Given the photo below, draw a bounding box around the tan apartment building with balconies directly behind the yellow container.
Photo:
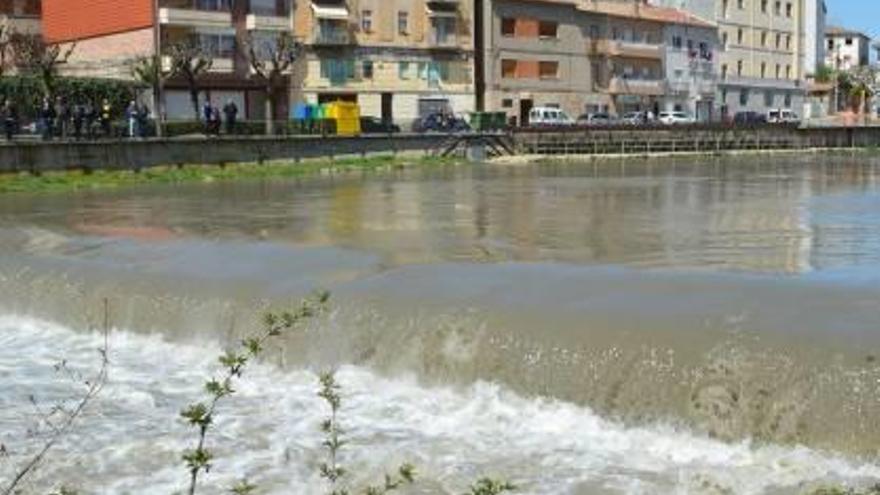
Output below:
[293,0,475,126]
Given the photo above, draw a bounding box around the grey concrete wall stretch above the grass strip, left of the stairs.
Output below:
[0,135,448,173]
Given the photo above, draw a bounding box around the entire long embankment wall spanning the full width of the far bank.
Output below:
[0,126,880,173]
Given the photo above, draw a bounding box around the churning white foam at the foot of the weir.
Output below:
[0,316,880,495]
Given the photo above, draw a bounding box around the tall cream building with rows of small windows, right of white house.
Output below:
[652,0,809,117]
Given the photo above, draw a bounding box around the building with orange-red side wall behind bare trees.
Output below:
[43,0,292,120]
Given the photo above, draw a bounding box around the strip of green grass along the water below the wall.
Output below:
[0,155,460,194]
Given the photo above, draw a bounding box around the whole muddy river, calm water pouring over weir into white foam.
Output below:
[0,153,880,495]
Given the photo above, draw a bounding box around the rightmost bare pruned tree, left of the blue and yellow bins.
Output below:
[242,31,302,135]
